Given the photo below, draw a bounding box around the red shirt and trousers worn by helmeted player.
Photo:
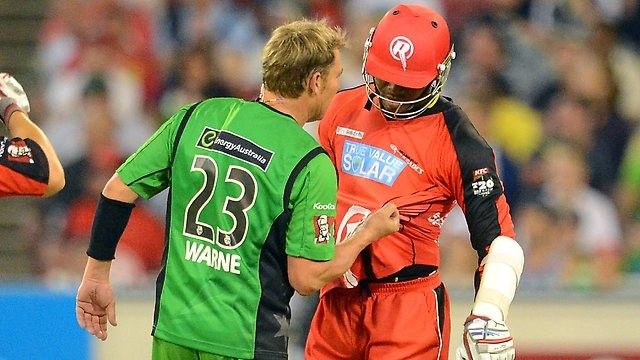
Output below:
[305,86,515,360]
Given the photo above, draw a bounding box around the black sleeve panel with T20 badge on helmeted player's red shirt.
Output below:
[443,103,502,258]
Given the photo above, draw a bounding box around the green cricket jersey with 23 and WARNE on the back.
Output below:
[118,98,337,359]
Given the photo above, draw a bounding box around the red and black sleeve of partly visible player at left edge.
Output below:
[0,137,49,197]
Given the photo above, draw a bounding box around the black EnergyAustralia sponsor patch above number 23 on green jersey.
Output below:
[196,127,273,171]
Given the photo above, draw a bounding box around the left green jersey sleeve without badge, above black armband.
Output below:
[116,107,188,199]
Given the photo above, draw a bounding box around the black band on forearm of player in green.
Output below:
[87,194,135,261]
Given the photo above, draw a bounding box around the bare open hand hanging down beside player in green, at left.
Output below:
[76,279,117,341]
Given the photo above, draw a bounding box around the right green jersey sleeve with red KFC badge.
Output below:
[286,153,338,261]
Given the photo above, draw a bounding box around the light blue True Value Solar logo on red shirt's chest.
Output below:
[341,140,407,186]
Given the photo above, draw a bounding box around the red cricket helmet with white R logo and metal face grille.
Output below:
[362,4,455,118]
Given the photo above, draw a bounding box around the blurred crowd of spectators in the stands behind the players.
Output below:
[0,0,640,291]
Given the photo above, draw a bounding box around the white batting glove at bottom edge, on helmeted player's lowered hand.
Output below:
[456,315,516,360]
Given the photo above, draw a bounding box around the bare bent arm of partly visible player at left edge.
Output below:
[8,111,65,196]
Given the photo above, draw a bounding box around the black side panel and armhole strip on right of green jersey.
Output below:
[255,147,324,360]
